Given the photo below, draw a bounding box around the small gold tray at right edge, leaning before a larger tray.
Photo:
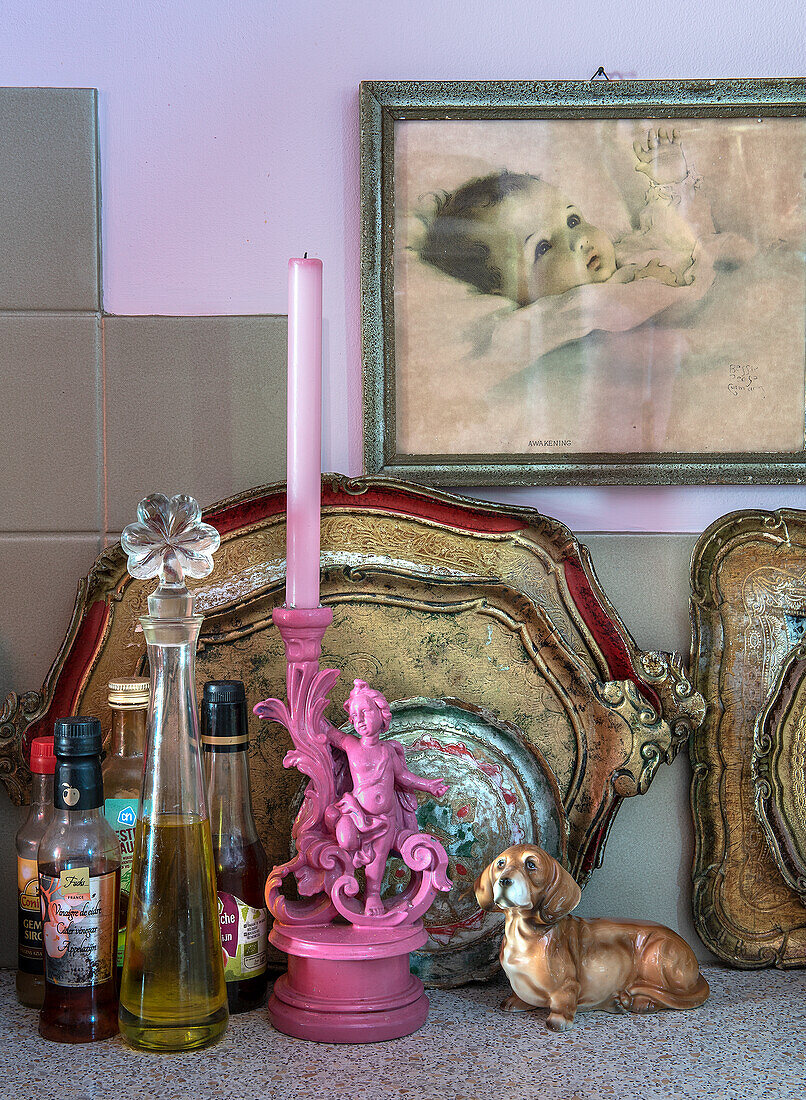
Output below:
[753,642,806,904]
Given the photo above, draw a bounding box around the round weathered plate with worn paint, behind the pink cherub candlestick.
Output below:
[378,699,567,987]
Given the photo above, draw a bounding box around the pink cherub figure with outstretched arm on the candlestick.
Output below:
[320,680,448,916]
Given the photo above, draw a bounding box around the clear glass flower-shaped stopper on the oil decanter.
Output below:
[120,493,221,618]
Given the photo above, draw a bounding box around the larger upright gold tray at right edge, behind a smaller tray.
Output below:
[691,509,806,968]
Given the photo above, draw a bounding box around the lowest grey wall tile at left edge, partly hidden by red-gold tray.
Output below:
[0,535,99,700]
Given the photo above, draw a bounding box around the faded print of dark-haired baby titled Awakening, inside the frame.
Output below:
[395,118,806,457]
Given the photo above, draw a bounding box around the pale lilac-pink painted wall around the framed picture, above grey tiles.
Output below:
[0,0,806,531]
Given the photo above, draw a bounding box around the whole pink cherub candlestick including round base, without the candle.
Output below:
[254,607,451,1043]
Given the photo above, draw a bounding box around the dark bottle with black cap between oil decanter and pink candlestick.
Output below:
[201,680,268,1013]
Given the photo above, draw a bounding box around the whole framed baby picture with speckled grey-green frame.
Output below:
[361,79,806,485]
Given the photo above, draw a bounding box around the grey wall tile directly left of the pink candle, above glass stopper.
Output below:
[104,316,287,530]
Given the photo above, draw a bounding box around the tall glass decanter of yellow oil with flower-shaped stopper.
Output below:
[119,495,229,1051]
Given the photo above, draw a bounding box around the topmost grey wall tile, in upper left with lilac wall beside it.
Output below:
[0,88,100,310]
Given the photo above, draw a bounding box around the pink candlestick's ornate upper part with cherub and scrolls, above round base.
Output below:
[254,608,450,928]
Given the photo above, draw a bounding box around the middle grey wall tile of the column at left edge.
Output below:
[0,314,102,532]
